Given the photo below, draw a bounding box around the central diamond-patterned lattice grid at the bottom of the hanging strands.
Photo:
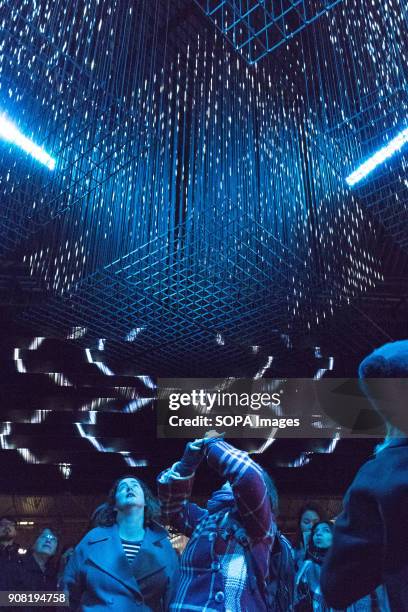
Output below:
[19,209,328,372]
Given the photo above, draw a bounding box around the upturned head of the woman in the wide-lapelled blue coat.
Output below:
[92,475,160,527]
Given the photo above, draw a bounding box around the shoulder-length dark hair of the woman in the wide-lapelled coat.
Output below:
[91,474,160,527]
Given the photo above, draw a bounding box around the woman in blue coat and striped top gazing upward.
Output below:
[63,476,178,612]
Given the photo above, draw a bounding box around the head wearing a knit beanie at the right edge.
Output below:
[358,340,408,435]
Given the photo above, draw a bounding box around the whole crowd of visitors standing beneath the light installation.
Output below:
[0,341,408,612]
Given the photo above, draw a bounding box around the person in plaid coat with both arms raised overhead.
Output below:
[158,434,277,612]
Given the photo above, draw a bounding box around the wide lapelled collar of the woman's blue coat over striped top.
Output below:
[87,523,167,596]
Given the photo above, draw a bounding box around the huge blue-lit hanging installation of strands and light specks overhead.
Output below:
[0,0,407,373]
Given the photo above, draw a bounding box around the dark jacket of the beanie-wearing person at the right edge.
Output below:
[321,438,408,612]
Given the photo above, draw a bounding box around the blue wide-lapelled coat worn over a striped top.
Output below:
[62,525,178,612]
